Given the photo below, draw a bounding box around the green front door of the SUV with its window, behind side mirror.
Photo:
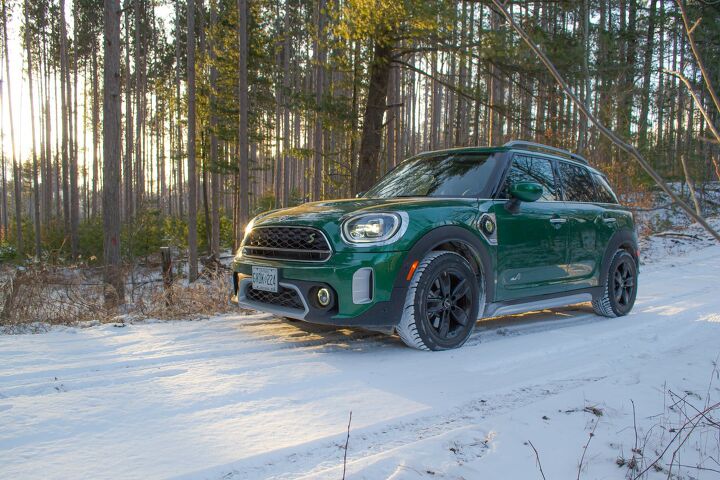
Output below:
[493,154,569,301]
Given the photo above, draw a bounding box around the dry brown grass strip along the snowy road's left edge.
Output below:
[0,258,238,333]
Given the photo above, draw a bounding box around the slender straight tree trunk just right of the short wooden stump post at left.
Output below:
[187,0,198,282]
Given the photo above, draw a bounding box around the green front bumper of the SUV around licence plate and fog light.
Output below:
[233,252,407,328]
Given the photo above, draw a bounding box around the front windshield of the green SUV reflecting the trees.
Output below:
[363,152,497,198]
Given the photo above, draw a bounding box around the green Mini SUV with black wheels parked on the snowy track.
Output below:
[233,141,638,350]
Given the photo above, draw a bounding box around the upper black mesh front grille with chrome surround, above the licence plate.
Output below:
[243,227,332,262]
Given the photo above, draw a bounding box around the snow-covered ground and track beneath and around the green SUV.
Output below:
[0,227,720,480]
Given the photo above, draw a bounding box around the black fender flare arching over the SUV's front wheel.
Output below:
[394,225,495,303]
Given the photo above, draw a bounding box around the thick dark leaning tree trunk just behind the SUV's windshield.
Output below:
[357,39,393,192]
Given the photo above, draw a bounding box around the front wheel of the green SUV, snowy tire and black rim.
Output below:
[396,251,480,350]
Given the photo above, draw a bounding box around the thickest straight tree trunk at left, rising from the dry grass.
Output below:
[102,0,125,305]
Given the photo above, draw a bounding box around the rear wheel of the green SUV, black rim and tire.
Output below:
[592,250,638,318]
